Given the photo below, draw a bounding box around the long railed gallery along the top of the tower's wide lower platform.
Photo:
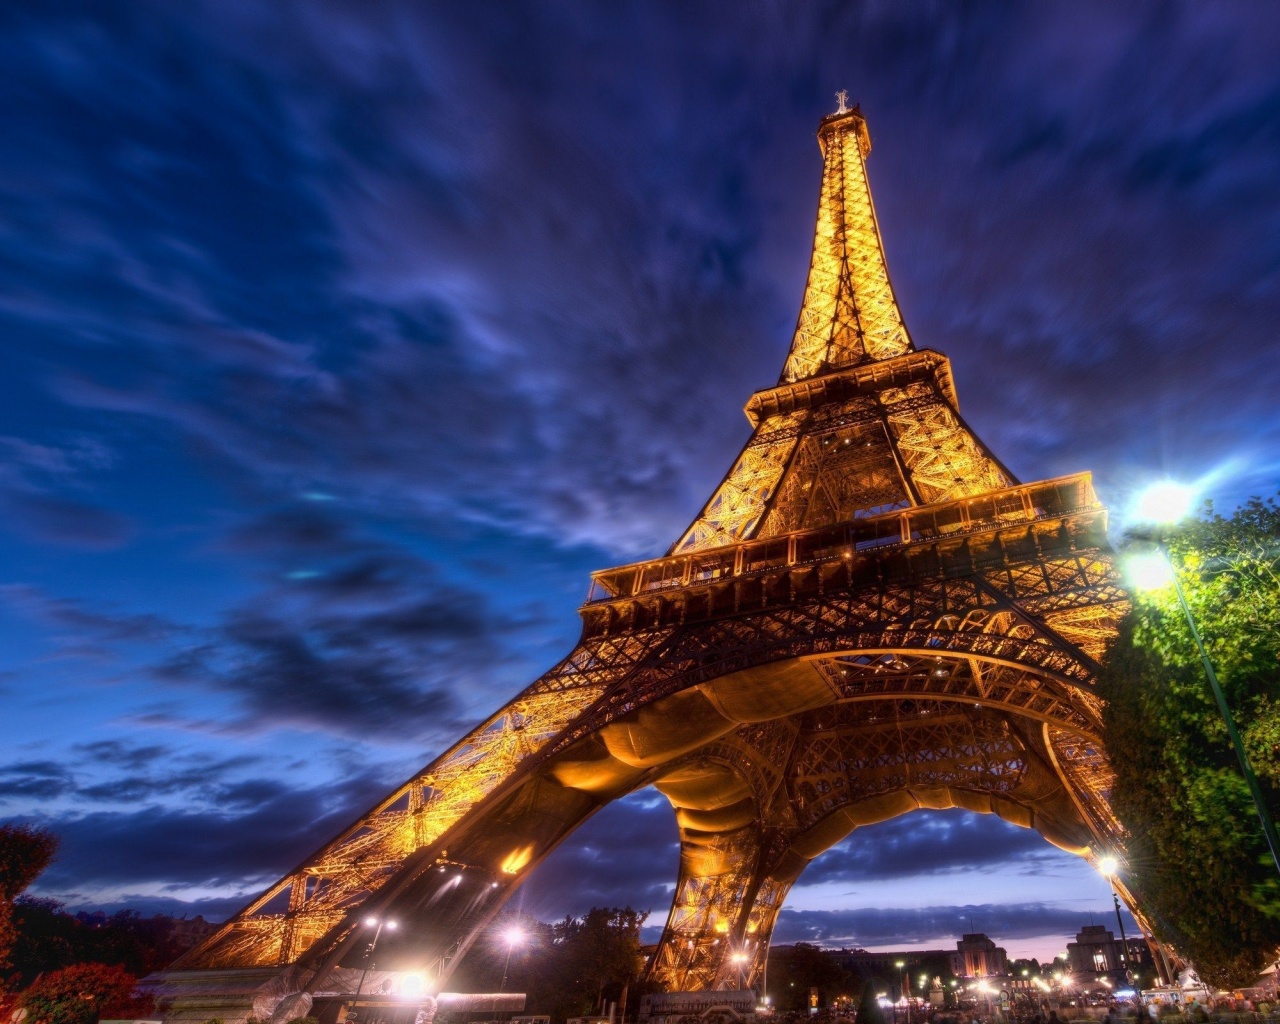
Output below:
[586,472,1101,604]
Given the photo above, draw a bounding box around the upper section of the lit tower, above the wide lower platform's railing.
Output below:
[671,108,1016,554]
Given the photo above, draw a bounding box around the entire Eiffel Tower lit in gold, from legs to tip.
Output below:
[162,101,1134,1020]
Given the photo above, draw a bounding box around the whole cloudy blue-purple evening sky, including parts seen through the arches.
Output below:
[0,0,1280,952]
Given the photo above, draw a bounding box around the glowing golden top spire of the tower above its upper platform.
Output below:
[782,104,914,383]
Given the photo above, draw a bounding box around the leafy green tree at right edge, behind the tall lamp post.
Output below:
[1098,498,1280,987]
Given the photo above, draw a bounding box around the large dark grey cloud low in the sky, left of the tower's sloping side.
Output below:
[155,540,527,741]
